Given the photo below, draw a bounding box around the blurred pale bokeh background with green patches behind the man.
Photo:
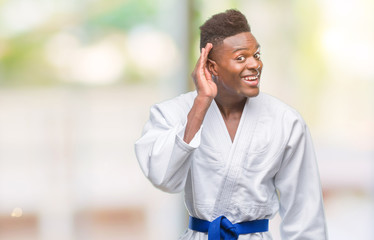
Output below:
[0,0,374,240]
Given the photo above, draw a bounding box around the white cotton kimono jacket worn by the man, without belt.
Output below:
[135,92,327,240]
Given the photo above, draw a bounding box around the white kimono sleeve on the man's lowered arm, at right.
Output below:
[275,113,327,240]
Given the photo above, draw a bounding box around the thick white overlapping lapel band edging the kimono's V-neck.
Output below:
[212,95,261,219]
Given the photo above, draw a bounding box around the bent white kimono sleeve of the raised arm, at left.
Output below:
[135,105,201,193]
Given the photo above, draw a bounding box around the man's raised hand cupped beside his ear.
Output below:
[192,43,217,100]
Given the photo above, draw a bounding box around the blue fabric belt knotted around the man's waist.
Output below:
[188,216,269,240]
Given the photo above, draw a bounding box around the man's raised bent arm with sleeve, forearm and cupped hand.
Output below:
[135,44,217,192]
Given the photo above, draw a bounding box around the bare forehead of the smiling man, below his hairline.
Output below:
[221,32,260,53]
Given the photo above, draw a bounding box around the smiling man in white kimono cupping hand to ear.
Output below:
[135,10,327,240]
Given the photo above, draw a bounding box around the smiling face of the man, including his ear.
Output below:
[208,32,263,97]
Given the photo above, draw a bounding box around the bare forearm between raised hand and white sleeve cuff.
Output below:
[183,96,213,144]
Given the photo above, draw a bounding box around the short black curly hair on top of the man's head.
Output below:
[200,9,251,49]
